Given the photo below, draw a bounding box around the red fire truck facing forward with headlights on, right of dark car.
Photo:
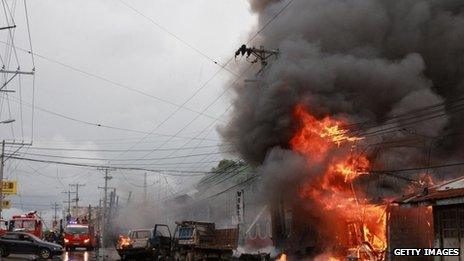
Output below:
[63,223,97,251]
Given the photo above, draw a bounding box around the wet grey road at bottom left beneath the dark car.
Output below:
[1,248,120,261]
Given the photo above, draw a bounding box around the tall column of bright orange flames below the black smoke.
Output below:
[289,105,387,260]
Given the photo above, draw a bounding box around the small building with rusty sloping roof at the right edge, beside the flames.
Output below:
[396,177,464,260]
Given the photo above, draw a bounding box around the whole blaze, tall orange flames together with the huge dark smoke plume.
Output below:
[220,0,464,260]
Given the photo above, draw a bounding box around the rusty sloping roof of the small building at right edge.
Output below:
[395,177,464,205]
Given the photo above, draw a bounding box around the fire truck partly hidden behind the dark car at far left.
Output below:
[8,211,43,238]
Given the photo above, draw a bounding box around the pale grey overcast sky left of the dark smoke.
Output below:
[0,0,256,223]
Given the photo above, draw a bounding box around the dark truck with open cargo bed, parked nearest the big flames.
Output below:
[172,221,238,261]
